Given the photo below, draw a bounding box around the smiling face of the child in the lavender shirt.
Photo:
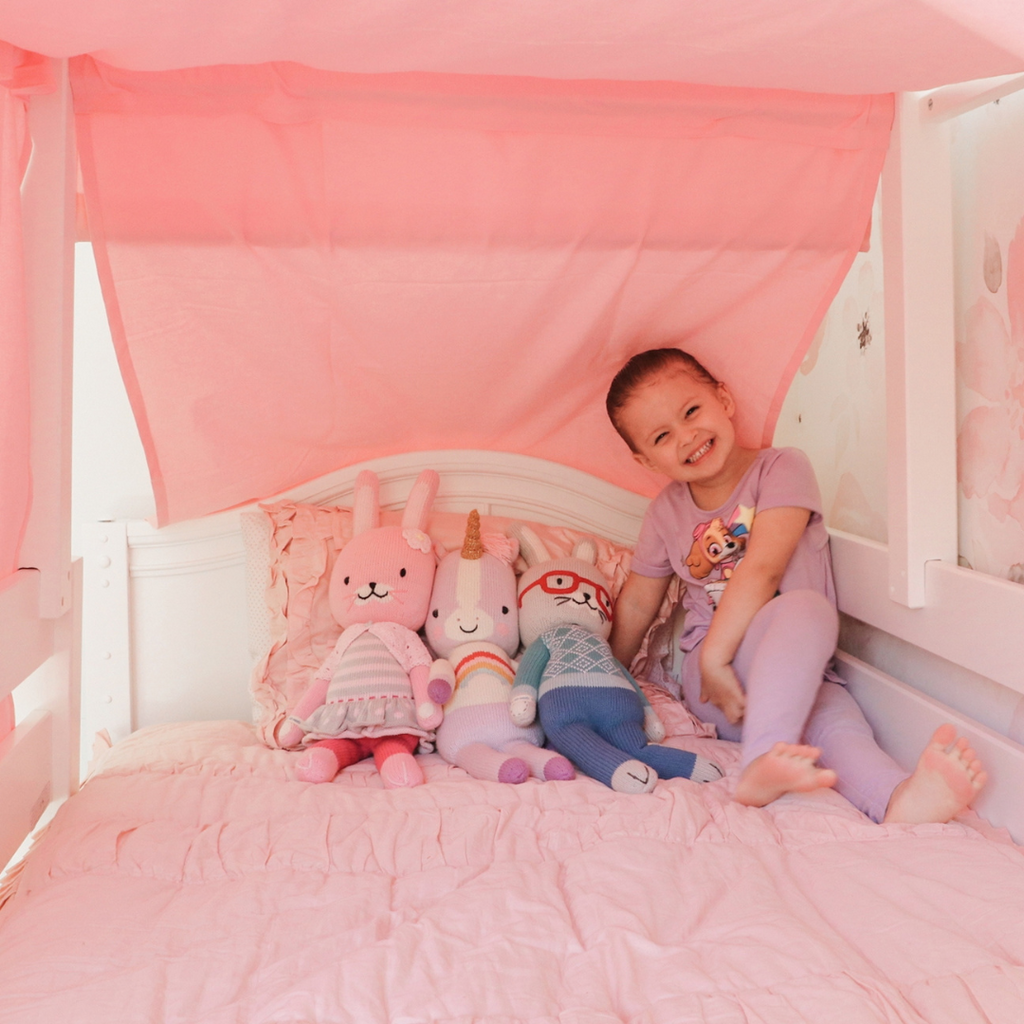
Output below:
[618,369,736,484]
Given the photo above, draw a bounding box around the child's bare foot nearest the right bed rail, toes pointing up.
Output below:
[882,722,988,824]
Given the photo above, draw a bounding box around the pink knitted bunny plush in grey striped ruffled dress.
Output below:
[278,470,452,788]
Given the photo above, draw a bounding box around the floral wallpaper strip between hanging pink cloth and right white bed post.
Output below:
[774,192,887,542]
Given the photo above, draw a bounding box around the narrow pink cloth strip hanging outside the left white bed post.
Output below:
[0,43,48,585]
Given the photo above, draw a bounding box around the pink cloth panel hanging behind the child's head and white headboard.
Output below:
[73,57,892,522]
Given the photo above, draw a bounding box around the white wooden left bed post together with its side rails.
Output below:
[0,60,81,868]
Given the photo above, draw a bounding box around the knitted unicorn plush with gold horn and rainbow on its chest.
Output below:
[427,510,575,782]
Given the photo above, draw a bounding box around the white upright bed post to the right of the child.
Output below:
[882,93,957,608]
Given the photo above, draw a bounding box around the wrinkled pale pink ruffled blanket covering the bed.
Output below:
[0,723,1024,1024]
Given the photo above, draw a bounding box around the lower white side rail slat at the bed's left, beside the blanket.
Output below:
[0,711,53,866]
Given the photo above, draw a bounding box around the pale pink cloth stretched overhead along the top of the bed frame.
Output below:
[0,0,1024,93]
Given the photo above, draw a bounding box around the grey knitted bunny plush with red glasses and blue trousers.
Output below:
[509,523,722,793]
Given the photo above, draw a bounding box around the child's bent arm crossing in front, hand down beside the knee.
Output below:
[700,507,811,722]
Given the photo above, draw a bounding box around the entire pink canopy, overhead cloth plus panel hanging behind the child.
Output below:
[0,0,1024,522]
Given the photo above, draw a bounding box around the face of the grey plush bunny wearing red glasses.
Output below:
[519,558,611,646]
